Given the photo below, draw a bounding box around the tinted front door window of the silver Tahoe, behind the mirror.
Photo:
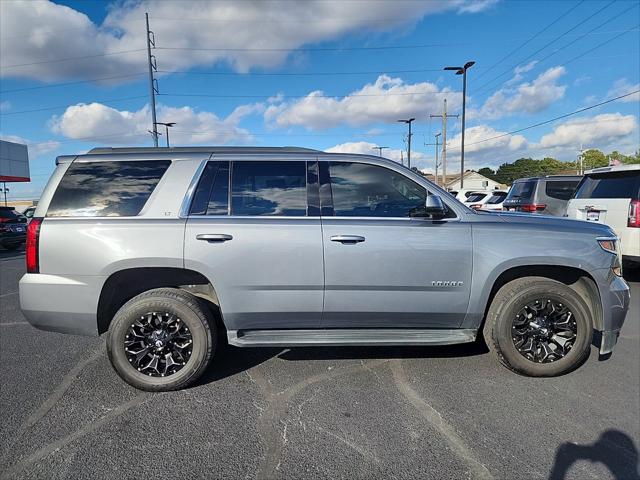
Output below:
[329,162,426,217]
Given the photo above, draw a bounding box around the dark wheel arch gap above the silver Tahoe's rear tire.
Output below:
[97,267,224,334]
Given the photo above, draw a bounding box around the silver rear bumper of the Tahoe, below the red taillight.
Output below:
[19,273,106,336]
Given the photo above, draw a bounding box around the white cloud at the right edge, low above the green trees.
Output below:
[540,113,638,149]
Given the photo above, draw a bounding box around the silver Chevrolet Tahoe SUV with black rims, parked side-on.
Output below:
[20,147,629,391]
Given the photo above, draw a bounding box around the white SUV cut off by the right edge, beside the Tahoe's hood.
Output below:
[567,165,640,268]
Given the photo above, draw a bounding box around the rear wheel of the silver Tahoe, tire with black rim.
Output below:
[107,288,217,392]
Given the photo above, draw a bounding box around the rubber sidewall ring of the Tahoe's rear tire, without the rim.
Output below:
[107,296,213,390]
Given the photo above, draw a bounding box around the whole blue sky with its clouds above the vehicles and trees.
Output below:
[0,0,640,198]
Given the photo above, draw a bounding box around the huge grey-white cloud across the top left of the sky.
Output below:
[0,0,495,81]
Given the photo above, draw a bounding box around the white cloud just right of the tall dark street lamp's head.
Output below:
[469,66,567,119]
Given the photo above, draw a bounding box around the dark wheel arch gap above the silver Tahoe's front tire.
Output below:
[480,265,604,331]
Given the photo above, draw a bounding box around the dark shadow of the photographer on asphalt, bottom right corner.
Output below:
[549,430,640,480]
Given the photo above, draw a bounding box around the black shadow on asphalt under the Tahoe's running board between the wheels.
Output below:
[194,341,489,386]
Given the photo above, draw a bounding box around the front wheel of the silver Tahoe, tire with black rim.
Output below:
[483,277,593,377]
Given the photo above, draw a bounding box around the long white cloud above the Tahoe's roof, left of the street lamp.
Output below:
[265,75,459,129]
